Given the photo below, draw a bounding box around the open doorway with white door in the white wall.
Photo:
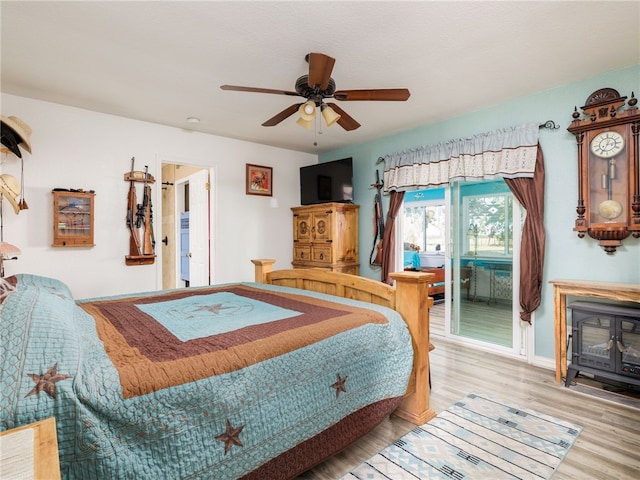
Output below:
[162,163,214,289]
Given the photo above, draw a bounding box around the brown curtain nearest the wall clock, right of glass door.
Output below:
[504,144,545,323]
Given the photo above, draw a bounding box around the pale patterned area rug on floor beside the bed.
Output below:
[341,394,582,480]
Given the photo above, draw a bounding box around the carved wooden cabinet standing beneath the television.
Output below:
[291,203,360,275]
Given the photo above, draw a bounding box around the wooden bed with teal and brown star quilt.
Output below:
[0,260,434,479]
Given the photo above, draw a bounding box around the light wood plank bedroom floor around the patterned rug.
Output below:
[298,312,640,480]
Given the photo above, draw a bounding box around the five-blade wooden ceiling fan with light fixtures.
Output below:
[220,53,411,131]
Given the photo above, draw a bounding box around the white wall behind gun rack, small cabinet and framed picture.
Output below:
[0,94,317,298]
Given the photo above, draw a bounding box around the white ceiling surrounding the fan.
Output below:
[0,1,640,153]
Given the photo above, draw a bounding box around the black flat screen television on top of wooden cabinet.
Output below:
[300,158,353,205]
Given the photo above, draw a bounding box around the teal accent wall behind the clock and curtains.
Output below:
[319,65,640,359]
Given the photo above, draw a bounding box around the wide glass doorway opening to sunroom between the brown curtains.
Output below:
[400,180,526,355]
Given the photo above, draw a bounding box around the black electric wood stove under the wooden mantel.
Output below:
[565,301,640,387]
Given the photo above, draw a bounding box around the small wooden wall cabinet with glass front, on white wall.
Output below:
[52,190,95,247]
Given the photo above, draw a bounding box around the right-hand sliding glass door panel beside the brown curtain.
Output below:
[451,181,520,349]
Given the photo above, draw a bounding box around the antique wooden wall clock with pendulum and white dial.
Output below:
[567,88,640,254]
